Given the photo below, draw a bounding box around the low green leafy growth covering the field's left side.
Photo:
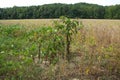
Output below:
[0,25,32,80]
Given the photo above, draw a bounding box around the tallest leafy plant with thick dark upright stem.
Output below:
[55,16,83,61]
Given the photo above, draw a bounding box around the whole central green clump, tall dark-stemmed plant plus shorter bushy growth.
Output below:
[27,16,83,63]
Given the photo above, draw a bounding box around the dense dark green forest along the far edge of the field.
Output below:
[0,3,120,19]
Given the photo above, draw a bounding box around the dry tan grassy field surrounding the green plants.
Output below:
[0,19,120,80]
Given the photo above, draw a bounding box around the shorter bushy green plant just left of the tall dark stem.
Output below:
[29,27,64,64]
